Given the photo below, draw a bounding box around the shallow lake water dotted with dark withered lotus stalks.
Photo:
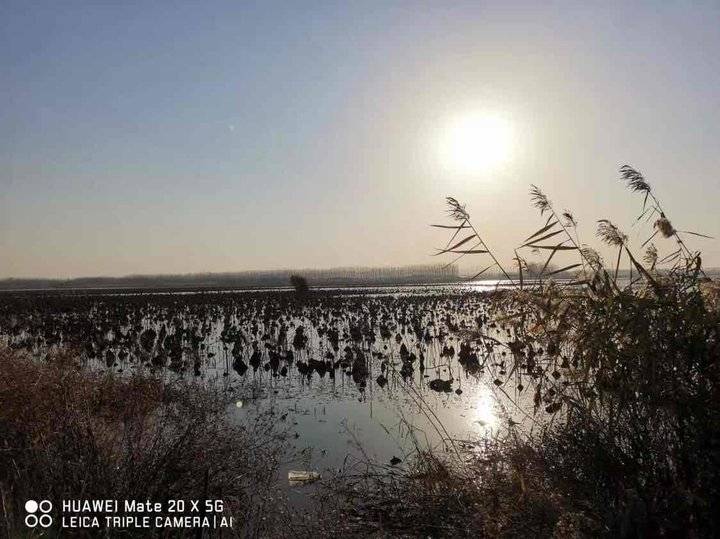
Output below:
[0,281,531,499]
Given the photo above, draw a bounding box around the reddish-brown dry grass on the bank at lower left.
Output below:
[0,351,283,537]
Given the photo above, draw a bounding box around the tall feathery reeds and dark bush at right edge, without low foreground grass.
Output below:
[416,162,720,537]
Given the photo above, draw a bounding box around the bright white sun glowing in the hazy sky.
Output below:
[439,112,513,174]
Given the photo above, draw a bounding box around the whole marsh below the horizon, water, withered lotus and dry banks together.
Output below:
[0,259,720,537]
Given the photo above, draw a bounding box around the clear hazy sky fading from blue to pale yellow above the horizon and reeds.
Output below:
[0,0,720,278]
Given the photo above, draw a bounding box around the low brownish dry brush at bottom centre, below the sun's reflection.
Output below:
[298,440,576,538]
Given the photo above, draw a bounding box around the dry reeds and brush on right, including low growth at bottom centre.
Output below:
[314,166,720,537]
